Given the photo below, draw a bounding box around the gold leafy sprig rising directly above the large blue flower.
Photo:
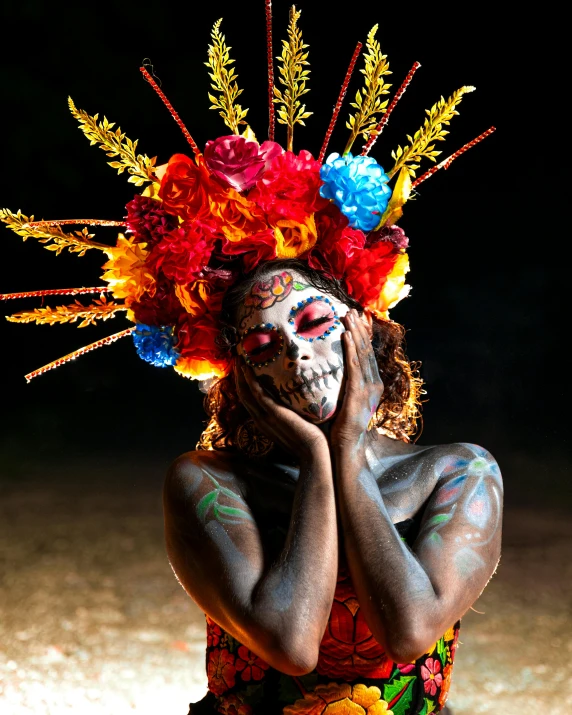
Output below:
[344,25,391,156]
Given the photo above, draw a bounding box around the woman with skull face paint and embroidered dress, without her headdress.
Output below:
[164,261,502,715]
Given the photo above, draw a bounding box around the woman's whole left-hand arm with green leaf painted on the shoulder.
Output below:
[164,366,338,675]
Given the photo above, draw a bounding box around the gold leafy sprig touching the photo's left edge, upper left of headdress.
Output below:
[0,209,111,256]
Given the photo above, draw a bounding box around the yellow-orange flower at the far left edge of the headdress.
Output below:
[101,233,155,304]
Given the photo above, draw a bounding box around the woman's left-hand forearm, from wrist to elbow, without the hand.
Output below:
[252,446,338,659]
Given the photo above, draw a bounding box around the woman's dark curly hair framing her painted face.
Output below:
[197,259,423,450]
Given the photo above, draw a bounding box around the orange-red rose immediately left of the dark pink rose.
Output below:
[159,154,211,219]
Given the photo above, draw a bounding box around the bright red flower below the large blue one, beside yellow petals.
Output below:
[344,241,401,305]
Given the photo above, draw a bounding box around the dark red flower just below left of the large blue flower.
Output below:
[308,204,366,278]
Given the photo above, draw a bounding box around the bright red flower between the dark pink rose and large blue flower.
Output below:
[249,150,328,223]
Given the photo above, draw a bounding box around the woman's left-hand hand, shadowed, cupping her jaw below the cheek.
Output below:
[235,359,329,462]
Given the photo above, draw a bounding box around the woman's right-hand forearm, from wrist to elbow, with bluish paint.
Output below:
[335,450,439,662]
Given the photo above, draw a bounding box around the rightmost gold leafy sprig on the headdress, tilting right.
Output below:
[388,85,475,178]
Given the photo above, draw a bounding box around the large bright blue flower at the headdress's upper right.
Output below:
[320,153,391,231]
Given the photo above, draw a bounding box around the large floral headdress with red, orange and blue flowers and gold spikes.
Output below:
[0,0,494,382]
